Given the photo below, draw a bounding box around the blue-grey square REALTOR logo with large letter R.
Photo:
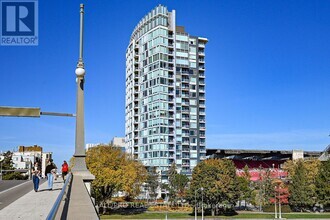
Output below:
[1,0,38,46]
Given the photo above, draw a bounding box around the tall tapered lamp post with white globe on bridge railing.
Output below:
[72,4,95,184]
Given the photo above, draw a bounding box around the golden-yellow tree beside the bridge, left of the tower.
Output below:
[86,145,147,208]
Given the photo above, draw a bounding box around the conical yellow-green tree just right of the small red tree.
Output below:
[289,160,313,210]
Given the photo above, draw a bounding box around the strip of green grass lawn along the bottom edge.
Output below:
[101,212,330,219]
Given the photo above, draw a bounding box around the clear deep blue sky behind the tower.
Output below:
[0,0,330,163]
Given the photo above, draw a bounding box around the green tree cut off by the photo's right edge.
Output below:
[315,160,330,206]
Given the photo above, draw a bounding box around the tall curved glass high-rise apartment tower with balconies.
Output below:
[125,5,208,181]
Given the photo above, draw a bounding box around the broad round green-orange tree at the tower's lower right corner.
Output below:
[187,159,239,216]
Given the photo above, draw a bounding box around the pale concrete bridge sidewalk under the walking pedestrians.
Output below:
[0,177,64,220]
